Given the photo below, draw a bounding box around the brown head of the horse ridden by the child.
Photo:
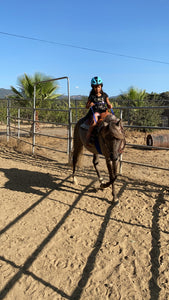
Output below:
[100,116,125,161]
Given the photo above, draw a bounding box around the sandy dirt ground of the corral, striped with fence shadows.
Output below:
[0,127,169,300]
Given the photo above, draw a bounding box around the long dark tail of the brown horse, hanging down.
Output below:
[73,122,83,168]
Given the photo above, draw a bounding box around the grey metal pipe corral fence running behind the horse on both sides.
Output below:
[0,91,169,172]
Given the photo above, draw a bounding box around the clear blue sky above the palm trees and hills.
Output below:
[0,0,169,96]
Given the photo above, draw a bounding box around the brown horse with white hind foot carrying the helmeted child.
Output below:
[73,114,125,201]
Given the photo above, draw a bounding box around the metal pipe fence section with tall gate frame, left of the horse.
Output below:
[7,76,72,161]
